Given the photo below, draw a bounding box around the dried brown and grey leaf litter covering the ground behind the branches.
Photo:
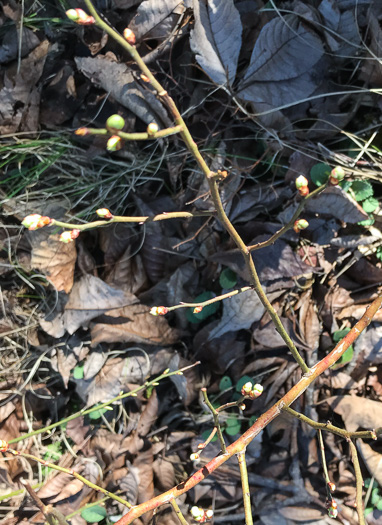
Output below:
[0,0,382,525]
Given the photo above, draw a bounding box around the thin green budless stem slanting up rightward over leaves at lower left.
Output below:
[9,361,200,444]
